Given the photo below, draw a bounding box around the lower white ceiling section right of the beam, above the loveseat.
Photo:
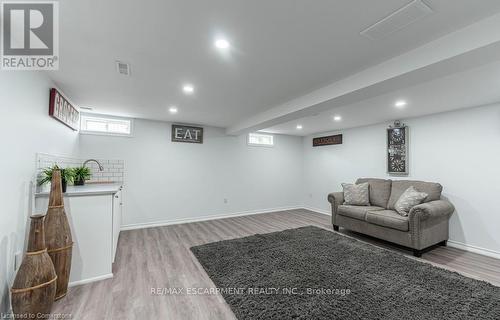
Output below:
[262,58,500,136]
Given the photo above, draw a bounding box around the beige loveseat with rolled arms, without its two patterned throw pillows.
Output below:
[328,178,455,257]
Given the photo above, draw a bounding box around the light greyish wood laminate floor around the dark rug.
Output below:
[53,210,500,320]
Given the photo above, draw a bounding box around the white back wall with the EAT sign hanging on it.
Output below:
[80,120,303,226]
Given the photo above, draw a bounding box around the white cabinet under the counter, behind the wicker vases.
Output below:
[35,185,123,285]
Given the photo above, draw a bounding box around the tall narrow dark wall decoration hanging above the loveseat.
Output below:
[387,121,409,175]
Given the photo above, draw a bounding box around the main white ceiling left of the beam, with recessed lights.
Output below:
[49,0,500,134]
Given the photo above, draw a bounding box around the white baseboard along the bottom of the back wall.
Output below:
[121,206,303,231]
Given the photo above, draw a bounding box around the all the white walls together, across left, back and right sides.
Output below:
[0,72,500,312]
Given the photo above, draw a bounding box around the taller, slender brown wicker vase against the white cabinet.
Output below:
[45,170,73,300]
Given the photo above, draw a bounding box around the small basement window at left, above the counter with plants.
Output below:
[80,115,132,136]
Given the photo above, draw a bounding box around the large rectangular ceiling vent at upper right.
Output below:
[361,0,433,40]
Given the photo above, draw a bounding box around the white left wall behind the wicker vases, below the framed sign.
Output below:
[0,71,78,312]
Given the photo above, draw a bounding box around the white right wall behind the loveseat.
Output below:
[303,104,500,253]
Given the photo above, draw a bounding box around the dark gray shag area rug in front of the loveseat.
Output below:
[191,226,500,320]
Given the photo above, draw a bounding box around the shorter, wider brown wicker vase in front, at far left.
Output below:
[11,215,57,319]
